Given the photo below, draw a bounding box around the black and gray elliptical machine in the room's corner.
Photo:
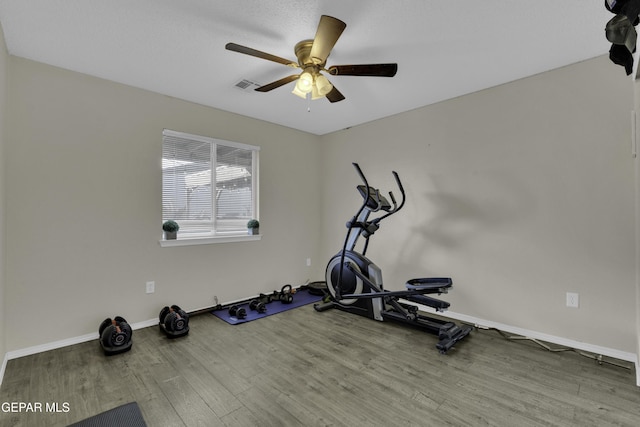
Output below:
[314,163,472,354]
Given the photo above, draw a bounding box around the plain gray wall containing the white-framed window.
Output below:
[3,57,321,351]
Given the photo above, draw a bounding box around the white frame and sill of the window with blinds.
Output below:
[160,129,261,247]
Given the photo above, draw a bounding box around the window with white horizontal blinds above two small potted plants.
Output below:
[162,129,260,238]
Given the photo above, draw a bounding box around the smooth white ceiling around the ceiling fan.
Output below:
[0,0,624,135]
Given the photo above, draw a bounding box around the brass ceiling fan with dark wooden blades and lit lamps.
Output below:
[225,15,398,102]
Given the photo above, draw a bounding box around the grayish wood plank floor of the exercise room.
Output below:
[0,305,640,427]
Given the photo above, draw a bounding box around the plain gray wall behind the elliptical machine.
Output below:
[322,56,638,354]
